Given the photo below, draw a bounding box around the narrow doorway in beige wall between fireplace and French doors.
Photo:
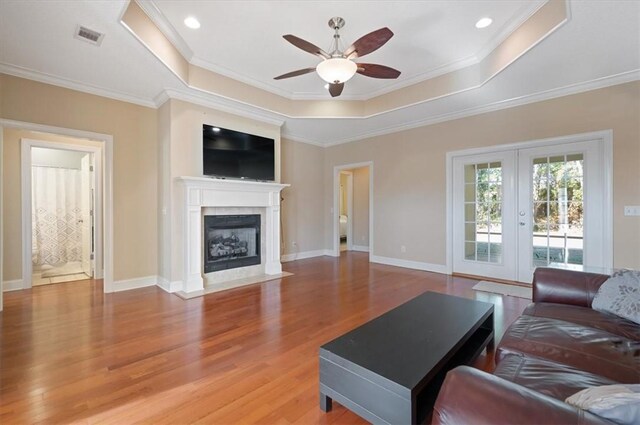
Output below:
[332,162,373,256]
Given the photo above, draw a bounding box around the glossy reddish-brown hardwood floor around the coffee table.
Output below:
[0,252,528,424]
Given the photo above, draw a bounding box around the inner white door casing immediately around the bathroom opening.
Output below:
[20,138,104,289]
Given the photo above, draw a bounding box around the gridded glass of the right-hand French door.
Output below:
[532,154,584,267]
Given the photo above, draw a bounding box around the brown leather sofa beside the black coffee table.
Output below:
[432,268,640,424]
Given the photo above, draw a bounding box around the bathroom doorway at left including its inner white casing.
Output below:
[21,138,103,289]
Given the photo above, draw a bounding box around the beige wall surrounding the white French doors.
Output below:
[324,82,640,268]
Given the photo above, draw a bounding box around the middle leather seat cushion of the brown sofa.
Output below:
[496,315,640,383]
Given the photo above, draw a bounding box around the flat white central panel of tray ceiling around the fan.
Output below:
[150,0,544,99]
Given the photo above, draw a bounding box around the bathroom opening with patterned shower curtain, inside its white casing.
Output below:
[31,146,95,286]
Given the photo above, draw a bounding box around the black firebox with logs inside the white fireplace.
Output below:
[204,214,261,273]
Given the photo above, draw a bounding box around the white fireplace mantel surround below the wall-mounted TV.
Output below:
[176,177,290,293]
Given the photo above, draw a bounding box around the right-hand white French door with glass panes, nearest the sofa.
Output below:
[518,141,606,282]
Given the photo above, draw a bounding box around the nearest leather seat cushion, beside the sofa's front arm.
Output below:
[494,354,617,401]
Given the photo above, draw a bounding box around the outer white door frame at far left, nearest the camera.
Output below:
[0,119,113,293]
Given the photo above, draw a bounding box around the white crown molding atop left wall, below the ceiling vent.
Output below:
[0,63,156,108]
